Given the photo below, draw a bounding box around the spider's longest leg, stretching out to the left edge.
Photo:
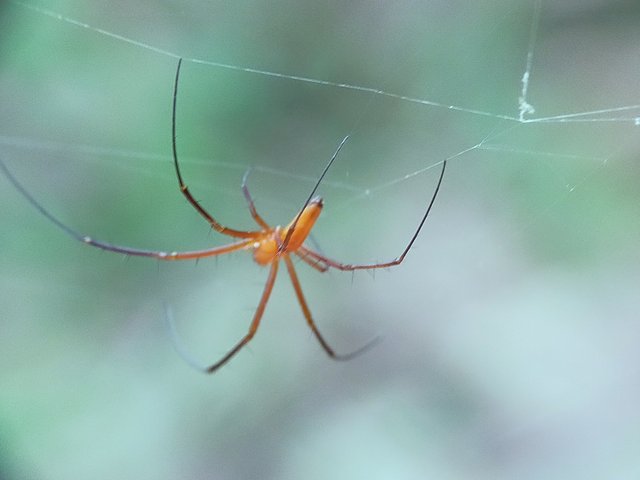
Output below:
[0,159,253,260]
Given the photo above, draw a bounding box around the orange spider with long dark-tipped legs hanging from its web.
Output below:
[0,59,446,373]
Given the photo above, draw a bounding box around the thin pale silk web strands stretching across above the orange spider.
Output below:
[0,0,640,207]
